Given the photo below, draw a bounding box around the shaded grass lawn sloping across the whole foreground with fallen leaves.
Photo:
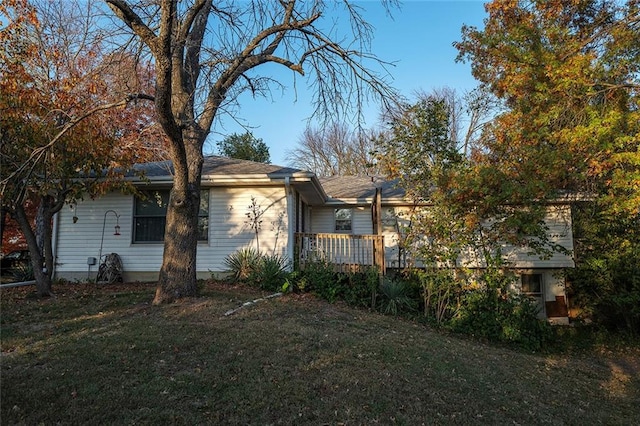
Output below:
[0,283,640,425]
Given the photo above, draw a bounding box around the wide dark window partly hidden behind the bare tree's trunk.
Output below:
[133,190,209,243]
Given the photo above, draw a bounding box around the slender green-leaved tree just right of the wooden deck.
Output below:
[378,95,475,322]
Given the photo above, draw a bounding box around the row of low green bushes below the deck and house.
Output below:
[292,260,552,351]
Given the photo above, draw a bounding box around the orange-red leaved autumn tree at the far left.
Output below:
[0,0,160,296]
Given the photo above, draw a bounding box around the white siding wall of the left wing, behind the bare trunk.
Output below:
[55,186,288,281]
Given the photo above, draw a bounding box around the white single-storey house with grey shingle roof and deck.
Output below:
[54,156,574,317]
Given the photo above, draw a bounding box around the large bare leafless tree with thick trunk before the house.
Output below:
[105,0,390,304]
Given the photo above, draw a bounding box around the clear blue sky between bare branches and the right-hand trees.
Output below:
[205,0,486,166]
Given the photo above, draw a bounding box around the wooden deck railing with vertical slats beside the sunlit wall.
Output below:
[296,233,385,274]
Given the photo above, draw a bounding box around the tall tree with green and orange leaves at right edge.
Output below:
[457,0,640,330]
